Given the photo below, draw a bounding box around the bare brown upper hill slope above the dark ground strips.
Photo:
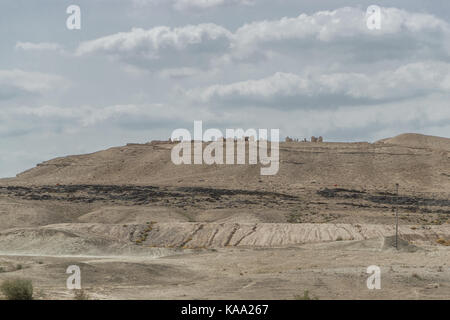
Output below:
[0,134,450,193]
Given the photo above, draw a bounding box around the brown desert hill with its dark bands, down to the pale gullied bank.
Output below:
[0,134,450,229]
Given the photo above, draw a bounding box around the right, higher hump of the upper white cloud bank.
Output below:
[233,7,450,58]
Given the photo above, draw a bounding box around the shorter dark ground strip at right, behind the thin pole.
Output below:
[317,188,450,214]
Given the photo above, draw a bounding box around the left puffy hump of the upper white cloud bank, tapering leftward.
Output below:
[76,23,232,70]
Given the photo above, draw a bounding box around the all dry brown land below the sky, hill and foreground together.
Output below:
[0,134,450,299]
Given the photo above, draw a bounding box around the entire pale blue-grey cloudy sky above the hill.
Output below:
[0,0,450,177]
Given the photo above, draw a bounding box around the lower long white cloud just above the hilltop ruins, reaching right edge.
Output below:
[186,62,450,107]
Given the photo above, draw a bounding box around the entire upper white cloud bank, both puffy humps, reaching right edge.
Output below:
[77,6,450,70]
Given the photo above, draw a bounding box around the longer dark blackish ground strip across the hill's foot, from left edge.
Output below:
[0,185,300,208]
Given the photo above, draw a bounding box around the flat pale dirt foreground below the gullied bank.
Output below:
[0,240,450,299]
